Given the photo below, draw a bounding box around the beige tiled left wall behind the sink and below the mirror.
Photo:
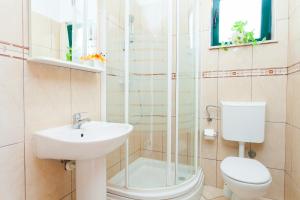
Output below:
[0,0,100,200]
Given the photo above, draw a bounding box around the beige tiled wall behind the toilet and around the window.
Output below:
[201,0,289,200]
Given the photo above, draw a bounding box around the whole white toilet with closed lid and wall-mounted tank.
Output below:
[220,101,272,200]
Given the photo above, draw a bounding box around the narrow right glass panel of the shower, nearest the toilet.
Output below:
[176,0,196,183]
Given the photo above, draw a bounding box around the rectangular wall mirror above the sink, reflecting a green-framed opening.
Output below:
[30,0,103,66]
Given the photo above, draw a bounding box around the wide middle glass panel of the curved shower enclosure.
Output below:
[128,0,168,188]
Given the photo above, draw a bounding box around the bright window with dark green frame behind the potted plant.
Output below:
[211,0,272,46]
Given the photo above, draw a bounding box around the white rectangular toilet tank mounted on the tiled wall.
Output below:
[221,101,266,143]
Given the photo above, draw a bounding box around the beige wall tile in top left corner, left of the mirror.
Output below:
[0,0,23,45]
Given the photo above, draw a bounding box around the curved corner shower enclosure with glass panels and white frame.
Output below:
[100,0,203,200]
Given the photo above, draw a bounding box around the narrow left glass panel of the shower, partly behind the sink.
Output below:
[105,0,125,187]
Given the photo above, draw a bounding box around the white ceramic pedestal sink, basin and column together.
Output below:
[33,121,133,200]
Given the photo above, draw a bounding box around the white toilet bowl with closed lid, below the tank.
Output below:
[221,157,272,200]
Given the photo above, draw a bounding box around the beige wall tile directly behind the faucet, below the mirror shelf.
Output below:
[71,69,100,120]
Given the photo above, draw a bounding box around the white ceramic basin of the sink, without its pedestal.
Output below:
[33,121,133,160]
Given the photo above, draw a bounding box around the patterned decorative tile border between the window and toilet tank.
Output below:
[202,67,288,78]
